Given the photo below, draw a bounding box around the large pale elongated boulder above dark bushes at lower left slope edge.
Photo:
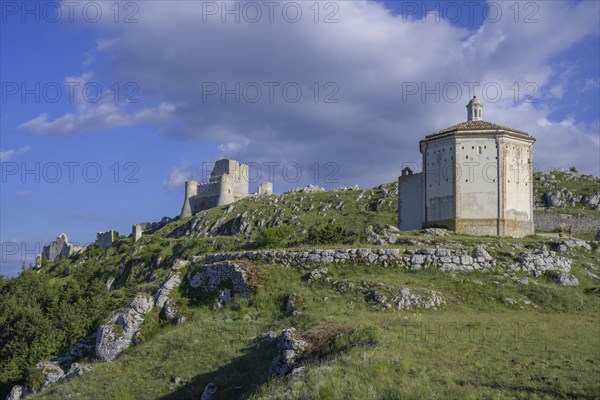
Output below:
[96,294,154,361]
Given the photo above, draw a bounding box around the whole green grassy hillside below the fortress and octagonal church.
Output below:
[0,180,600,399]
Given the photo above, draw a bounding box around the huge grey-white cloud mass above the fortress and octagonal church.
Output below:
[22,1,600,187]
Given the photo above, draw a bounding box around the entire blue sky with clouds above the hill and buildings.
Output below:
[0,0,600,275]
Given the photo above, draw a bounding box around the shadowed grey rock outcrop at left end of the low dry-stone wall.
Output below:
[189,261,251,297]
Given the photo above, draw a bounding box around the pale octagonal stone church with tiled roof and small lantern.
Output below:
[398,97,535,237]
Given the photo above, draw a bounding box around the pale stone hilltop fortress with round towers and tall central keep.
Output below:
[180,159,273,217]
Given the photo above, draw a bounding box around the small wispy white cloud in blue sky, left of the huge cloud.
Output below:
[19,72,175,136]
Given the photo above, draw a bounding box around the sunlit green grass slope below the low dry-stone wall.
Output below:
[32,266,600,400]
